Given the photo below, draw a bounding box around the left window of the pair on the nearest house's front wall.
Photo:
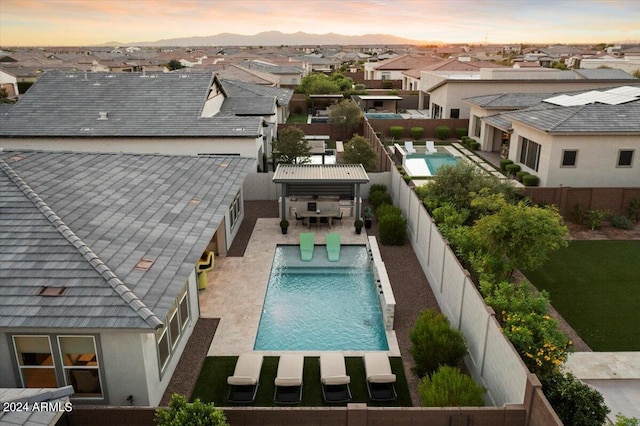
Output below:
[13,336,58,388]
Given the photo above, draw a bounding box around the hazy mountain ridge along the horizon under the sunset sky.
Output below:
[114,31,433,46]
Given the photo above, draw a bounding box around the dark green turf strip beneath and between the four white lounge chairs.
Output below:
[191,356,411,407]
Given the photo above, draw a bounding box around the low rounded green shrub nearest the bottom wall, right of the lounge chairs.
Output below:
[418,366,486,407]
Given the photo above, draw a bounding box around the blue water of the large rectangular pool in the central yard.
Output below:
[254,245,389,351]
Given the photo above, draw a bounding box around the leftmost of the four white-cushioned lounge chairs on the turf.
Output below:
[227,353,263,404]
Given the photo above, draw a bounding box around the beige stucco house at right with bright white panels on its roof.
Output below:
[468,84,640,187]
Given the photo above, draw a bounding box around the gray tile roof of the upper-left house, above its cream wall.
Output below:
[0,71,261,138]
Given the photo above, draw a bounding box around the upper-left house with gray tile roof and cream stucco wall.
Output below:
[0,71,276,165]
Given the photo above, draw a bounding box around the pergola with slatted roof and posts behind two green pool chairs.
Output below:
[272,164,369,219]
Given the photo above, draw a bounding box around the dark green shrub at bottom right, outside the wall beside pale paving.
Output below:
[540,373,609,426]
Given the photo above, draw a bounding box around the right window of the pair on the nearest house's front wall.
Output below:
[58,336,103,398]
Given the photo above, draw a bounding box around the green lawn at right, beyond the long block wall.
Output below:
[526,240,640,352]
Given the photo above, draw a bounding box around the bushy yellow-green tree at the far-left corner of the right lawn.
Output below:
[471,200,568,275]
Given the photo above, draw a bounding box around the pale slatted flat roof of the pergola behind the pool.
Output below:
[273,164,369,183]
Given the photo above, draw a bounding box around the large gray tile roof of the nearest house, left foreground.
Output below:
[0,151,255,329]
